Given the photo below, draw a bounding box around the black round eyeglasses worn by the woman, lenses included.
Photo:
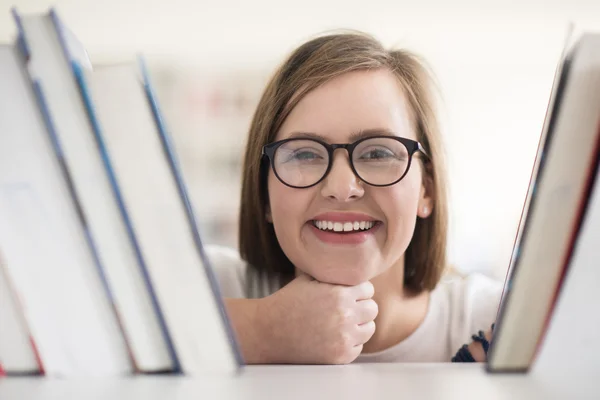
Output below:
[262,135,429,189]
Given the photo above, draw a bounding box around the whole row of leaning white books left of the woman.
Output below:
[0,9,242,377]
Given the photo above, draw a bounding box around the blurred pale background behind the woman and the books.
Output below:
[0,0,600,279]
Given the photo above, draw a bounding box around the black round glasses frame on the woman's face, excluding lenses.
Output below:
[261,135,430,189]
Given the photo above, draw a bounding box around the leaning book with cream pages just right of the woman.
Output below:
[486,33,600,372]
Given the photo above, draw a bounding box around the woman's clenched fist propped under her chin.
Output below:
[259,274,378,364]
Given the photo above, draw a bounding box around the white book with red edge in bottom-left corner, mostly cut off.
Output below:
[0,247,41,374]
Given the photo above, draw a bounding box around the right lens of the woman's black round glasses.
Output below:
[352,138,410,185]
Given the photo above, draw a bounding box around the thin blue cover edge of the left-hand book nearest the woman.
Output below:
[139,58,244,367]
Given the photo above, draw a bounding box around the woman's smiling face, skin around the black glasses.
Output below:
[267,69,432,285]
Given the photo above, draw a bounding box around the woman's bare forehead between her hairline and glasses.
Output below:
[276,69,416,143]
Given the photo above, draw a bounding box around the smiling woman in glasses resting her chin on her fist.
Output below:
[209,32,502,363]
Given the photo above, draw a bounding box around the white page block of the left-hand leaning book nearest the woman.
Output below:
[83,60,241,376]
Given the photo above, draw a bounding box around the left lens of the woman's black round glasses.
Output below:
[274,139,329,187]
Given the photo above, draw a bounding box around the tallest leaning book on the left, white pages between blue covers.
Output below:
[12,10,177,372]
